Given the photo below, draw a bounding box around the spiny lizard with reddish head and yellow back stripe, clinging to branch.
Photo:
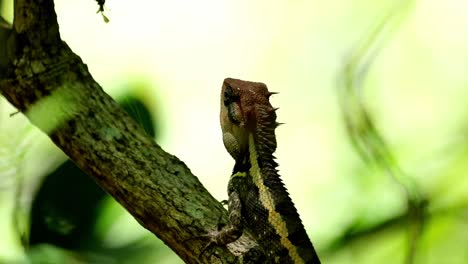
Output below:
[209,78,320,264]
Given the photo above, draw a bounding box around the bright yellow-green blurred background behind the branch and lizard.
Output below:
[0,0,468,264]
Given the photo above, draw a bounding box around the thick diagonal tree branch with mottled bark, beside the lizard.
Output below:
[0,0,253,263]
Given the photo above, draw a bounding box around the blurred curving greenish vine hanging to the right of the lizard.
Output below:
[338,1,427,263]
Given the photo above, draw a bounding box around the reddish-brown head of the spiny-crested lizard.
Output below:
[220,78,273,161]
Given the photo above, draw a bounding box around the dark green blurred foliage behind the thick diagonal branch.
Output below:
[23,95,166,263]
